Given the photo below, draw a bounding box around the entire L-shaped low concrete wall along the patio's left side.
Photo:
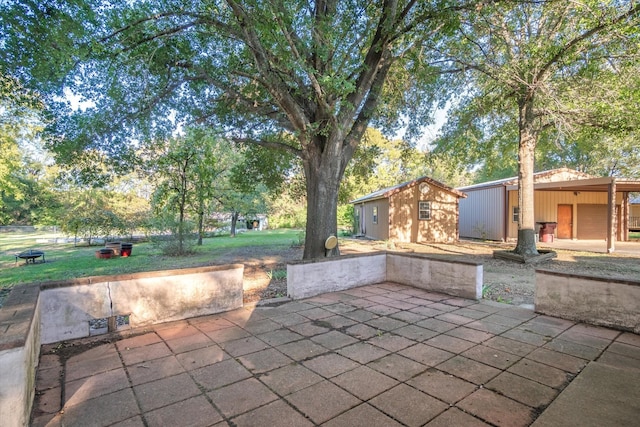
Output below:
[0,264,244,427]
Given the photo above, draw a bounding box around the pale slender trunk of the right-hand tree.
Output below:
[515,97,539,257]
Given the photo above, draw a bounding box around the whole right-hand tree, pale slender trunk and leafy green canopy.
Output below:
[432,1,640,256]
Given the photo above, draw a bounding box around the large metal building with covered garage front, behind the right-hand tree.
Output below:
[458,168,640,251]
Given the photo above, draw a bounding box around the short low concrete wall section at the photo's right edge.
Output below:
[535,269,640,334]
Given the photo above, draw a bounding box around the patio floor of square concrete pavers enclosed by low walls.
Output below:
[32,283,640,427]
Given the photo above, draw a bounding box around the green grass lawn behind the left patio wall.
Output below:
[0,229,300,289]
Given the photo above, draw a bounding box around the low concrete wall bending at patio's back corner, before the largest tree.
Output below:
[287,252,482,299]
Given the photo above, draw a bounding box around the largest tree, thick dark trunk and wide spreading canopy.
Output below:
[2,0,461,258]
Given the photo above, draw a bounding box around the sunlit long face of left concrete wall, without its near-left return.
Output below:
[40,265,244,344]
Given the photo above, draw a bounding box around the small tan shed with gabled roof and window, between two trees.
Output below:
[351,177,466,243]
